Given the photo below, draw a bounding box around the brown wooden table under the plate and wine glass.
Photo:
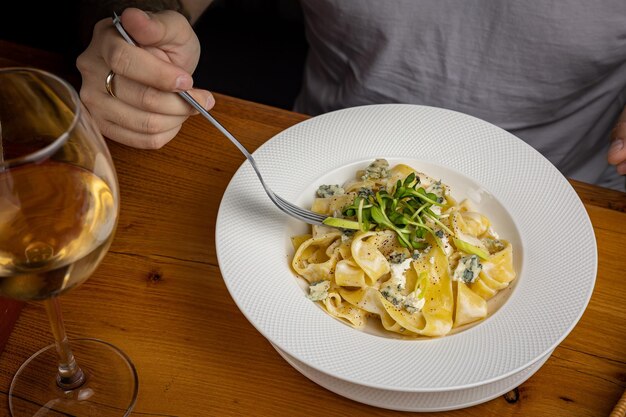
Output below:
[0,41,626,417]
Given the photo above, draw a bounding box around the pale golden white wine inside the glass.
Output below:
[0,162,118,300]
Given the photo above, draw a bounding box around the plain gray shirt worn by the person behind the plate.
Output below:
[295,0,626,191]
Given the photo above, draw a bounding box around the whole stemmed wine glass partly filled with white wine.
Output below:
[0,68,138,417]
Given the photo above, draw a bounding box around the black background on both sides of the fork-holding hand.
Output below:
[0,0,307,109]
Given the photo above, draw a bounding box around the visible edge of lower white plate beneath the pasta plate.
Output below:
[274,346,552,412]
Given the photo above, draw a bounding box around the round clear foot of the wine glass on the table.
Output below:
[9,339,138,417]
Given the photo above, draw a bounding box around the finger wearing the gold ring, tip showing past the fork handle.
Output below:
[107,75,215,116]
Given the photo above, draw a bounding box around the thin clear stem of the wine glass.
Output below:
[43,297,85,390]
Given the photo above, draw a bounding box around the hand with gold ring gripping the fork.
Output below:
[76,8,215,149]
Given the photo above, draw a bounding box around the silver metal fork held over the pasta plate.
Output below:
[113,12,327,225]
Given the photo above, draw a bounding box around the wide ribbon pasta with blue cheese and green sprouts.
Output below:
[291,159,516,337]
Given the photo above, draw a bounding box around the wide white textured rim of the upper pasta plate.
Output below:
[215,104,597,392]
